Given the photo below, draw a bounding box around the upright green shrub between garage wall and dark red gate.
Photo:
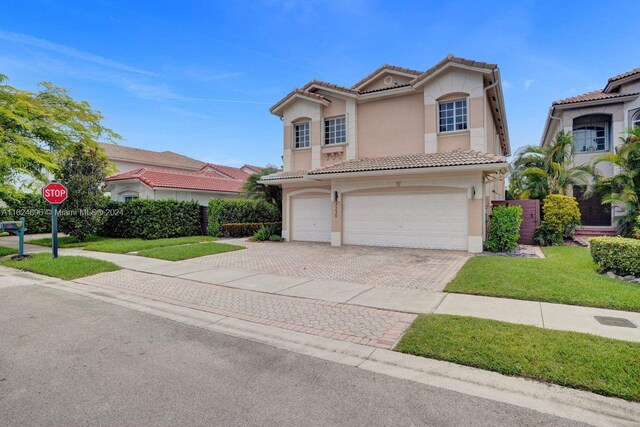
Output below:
[485,205,522,252]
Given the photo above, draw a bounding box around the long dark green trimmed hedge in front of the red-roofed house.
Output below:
[99,199,201,240]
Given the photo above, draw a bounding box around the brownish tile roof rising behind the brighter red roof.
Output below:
[100,143,204,169]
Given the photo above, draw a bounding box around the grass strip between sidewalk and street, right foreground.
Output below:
[396,314,640,401]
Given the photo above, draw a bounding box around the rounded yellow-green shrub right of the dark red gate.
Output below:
[535,194,580,245]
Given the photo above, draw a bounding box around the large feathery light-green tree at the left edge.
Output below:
[0,74,120,193]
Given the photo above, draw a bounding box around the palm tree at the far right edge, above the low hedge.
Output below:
[594,126,640,236]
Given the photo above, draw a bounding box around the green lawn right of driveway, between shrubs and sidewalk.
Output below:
[445,246,640,311]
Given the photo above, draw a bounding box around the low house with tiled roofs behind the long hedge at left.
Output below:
[102,144,262,206]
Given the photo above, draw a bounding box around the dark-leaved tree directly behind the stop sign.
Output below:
[56,142,113,241]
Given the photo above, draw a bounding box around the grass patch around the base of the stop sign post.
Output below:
[0,253,120,280]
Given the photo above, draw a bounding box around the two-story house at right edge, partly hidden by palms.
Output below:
[541,68,640,226]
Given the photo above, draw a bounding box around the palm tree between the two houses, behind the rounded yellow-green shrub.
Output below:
[510,131,594,199]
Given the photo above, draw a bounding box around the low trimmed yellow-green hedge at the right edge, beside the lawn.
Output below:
[589,237,640,276]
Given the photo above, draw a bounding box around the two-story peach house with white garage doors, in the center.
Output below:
[261,55,510,252]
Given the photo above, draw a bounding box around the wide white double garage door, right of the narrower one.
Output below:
[343,192,467,250]
